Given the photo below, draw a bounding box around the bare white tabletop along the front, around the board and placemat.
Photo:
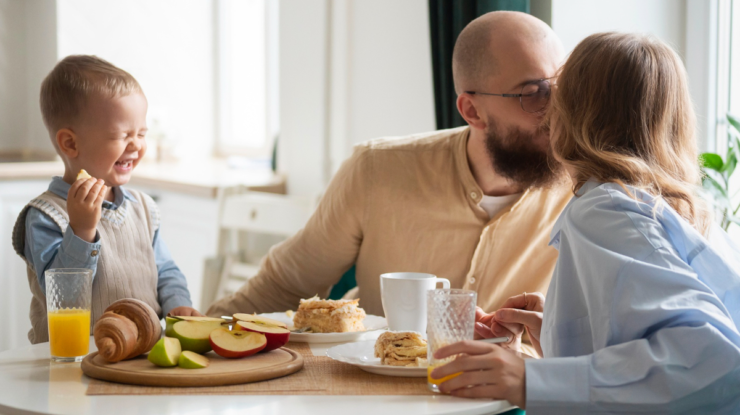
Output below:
[0,338,514,415]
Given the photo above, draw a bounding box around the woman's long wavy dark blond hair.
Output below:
[549,33,711,234]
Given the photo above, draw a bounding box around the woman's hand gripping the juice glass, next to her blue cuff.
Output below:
[431,340,526,409]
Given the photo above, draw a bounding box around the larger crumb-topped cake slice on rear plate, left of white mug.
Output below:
[293,296,365,333]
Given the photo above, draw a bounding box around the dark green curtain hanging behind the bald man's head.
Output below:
[429,0,529,130]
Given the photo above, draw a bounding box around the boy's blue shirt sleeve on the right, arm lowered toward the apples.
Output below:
[152,229,193,316]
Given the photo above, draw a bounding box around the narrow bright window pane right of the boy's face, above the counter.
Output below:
[216,0,278,158]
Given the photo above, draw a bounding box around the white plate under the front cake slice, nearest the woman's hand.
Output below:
[326,340,427,378]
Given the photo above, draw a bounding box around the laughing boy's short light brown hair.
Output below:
[40,55,142,136]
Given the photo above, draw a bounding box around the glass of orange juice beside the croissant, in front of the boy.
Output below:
[45,268,92,362]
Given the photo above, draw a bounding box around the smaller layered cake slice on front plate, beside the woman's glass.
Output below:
[375,331,427,367]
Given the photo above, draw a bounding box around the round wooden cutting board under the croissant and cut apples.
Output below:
[82,347,303,386]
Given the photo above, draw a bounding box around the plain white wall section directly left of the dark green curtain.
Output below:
[336,0,436,150]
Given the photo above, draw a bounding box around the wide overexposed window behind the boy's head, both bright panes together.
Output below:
[56,0,278,160]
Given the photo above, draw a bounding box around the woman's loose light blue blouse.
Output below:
[526,181,740,415]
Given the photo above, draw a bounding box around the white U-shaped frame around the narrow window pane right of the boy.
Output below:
[214,0,279,159]
